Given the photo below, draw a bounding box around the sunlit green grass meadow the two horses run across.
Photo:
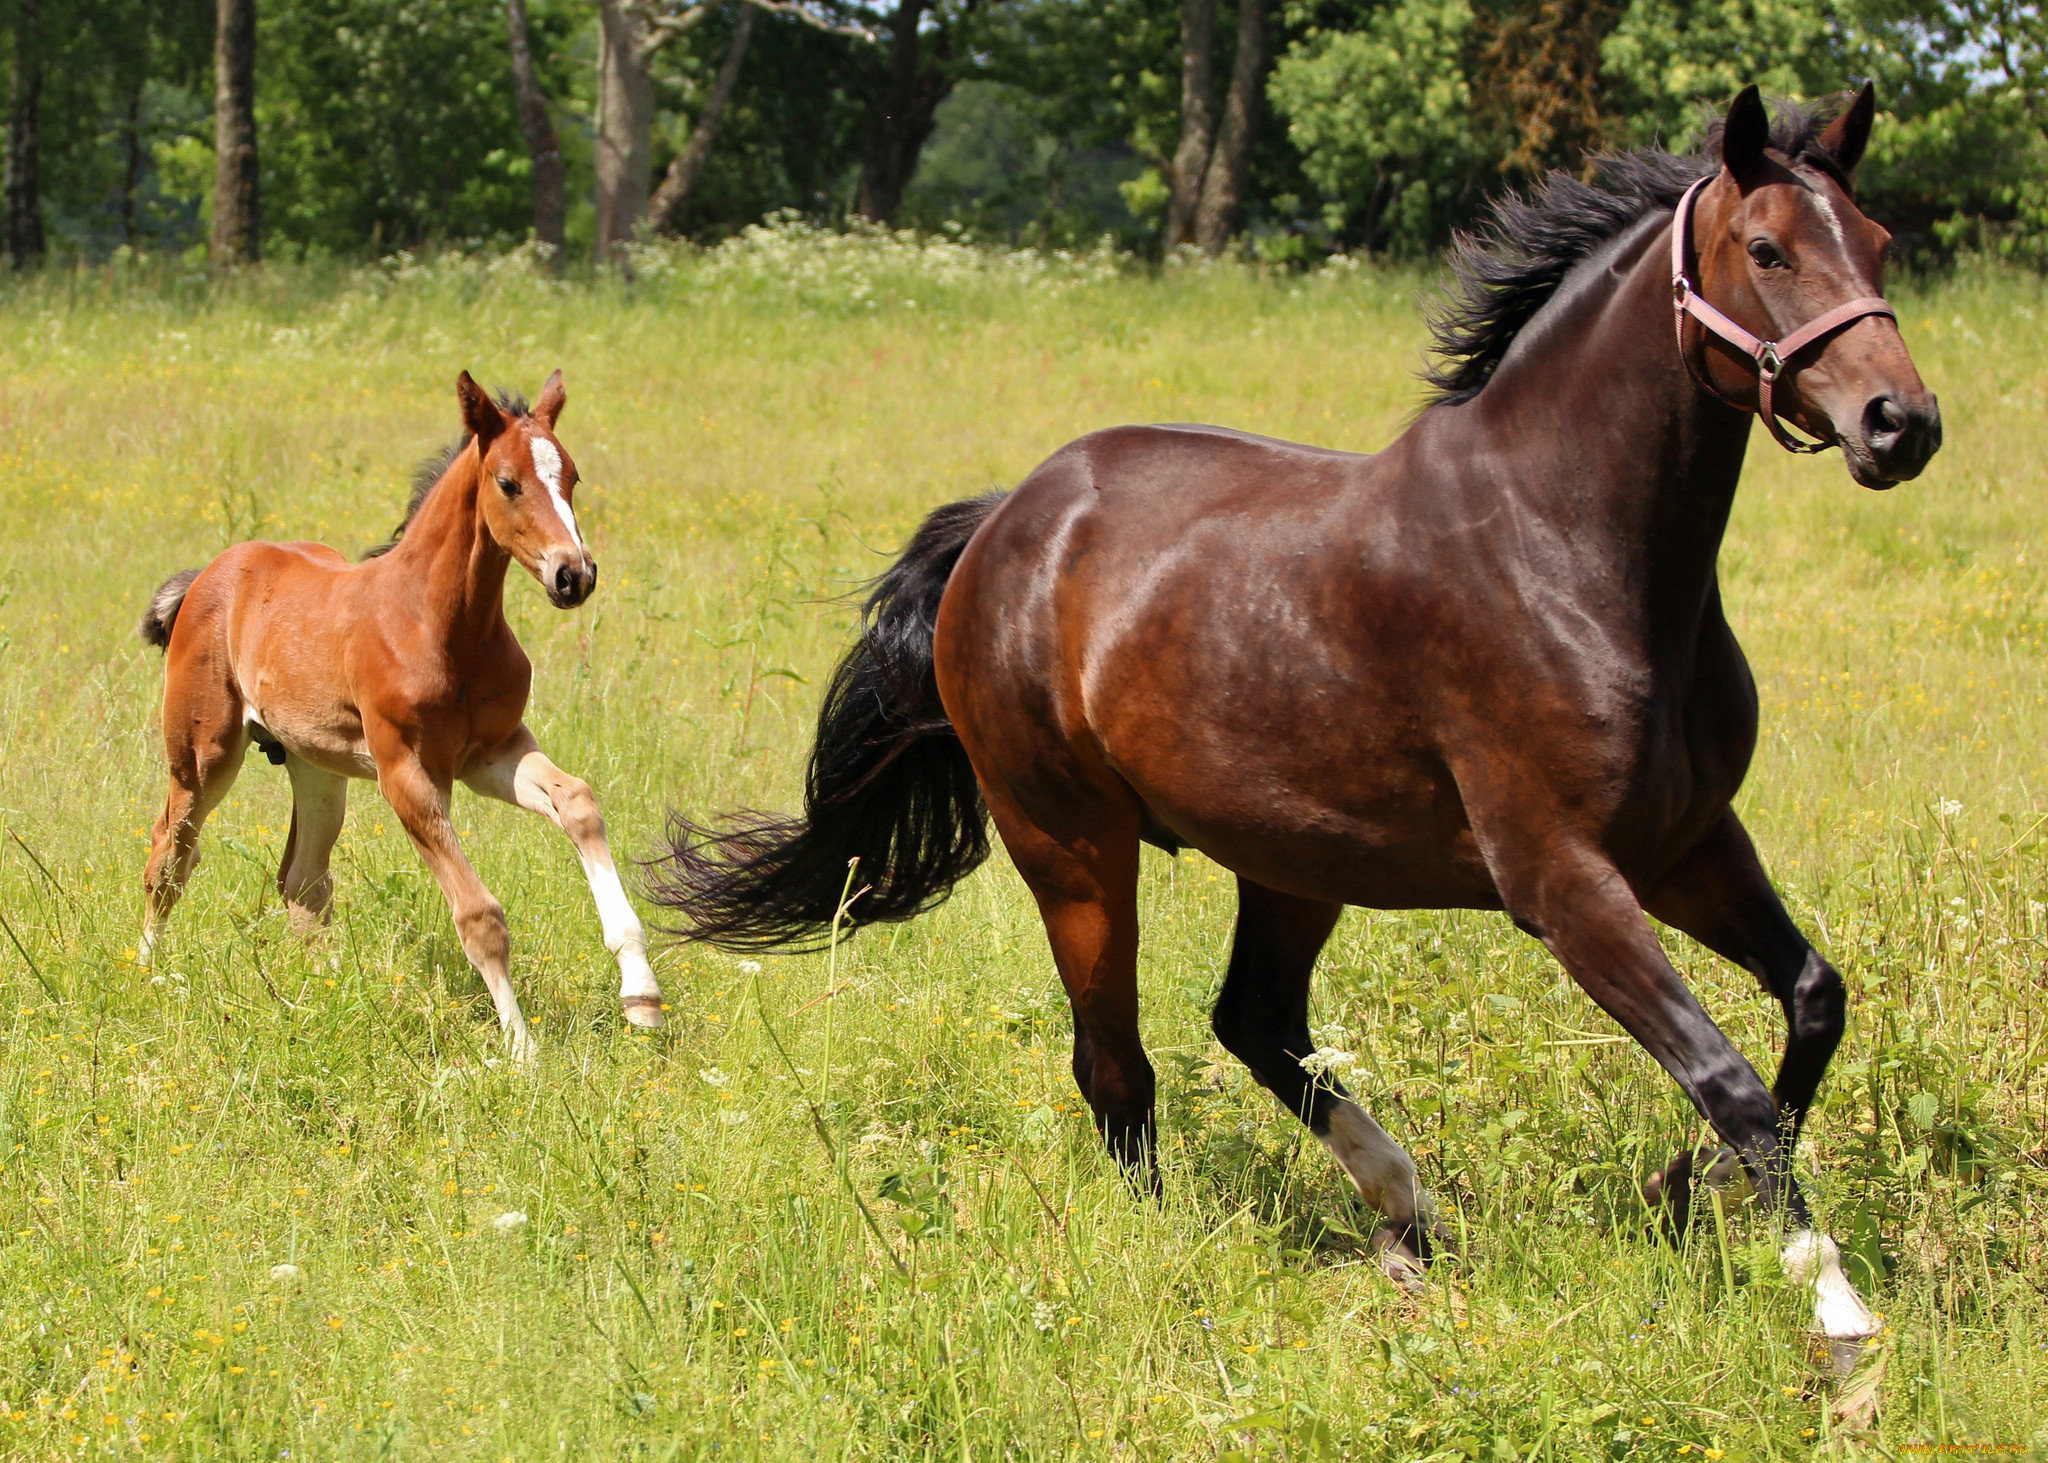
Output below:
[0,232,2048,1463]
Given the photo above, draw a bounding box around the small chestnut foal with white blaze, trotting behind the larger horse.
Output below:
[139,371,662,1059]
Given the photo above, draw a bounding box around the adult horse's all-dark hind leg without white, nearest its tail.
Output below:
[989,795,1159,1193]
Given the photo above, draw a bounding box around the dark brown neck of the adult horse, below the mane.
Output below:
[1479,207,1749,637]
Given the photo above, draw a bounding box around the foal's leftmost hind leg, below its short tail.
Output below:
[135,670,248,965]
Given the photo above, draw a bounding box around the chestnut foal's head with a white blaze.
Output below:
[455,371,598,609]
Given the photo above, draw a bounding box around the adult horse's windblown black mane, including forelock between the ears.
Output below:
[1423,100,1849,402]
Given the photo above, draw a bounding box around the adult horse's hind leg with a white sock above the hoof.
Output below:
[1210,879,1442,1291]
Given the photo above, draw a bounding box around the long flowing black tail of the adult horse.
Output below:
[651,494,1001,951]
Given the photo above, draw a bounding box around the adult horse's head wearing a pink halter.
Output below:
[1688,84,1942,488]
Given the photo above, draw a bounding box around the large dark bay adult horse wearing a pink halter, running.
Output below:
[655,86,1942,1365]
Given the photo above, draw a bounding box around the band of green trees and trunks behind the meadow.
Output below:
[0,0,2048,268]
